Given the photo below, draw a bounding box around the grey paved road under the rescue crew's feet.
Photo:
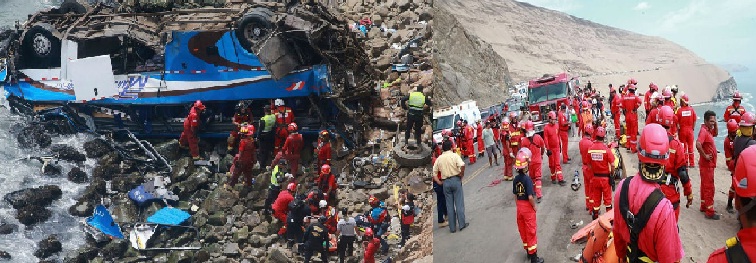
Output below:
[433,137,591,263]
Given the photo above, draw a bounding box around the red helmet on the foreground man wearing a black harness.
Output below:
[638,123,669,166]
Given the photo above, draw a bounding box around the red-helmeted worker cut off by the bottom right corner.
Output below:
[707,147,756,263]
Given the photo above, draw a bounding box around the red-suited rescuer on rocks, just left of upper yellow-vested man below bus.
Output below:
[228,125,257,187]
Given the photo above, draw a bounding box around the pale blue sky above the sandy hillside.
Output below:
[518,0,756,69]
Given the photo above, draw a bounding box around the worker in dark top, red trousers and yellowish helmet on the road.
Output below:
[512,148,543,263]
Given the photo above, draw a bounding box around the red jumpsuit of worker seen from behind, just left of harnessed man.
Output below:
[588,141,614,216]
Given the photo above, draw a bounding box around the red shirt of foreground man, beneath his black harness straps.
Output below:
[612,175,683,263]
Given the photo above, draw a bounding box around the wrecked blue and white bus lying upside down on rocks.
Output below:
[0,1,375,145]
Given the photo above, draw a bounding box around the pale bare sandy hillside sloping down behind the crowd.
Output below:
[435,0,730,105]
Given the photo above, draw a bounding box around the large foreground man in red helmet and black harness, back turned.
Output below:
[612,124,683,263]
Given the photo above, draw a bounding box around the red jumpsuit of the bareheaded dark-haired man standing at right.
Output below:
[697,124,717,216]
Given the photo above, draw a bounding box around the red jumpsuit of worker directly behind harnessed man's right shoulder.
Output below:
[660,136,693,219]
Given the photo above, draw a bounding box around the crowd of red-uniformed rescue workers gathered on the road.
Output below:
[434,79,756,263]
